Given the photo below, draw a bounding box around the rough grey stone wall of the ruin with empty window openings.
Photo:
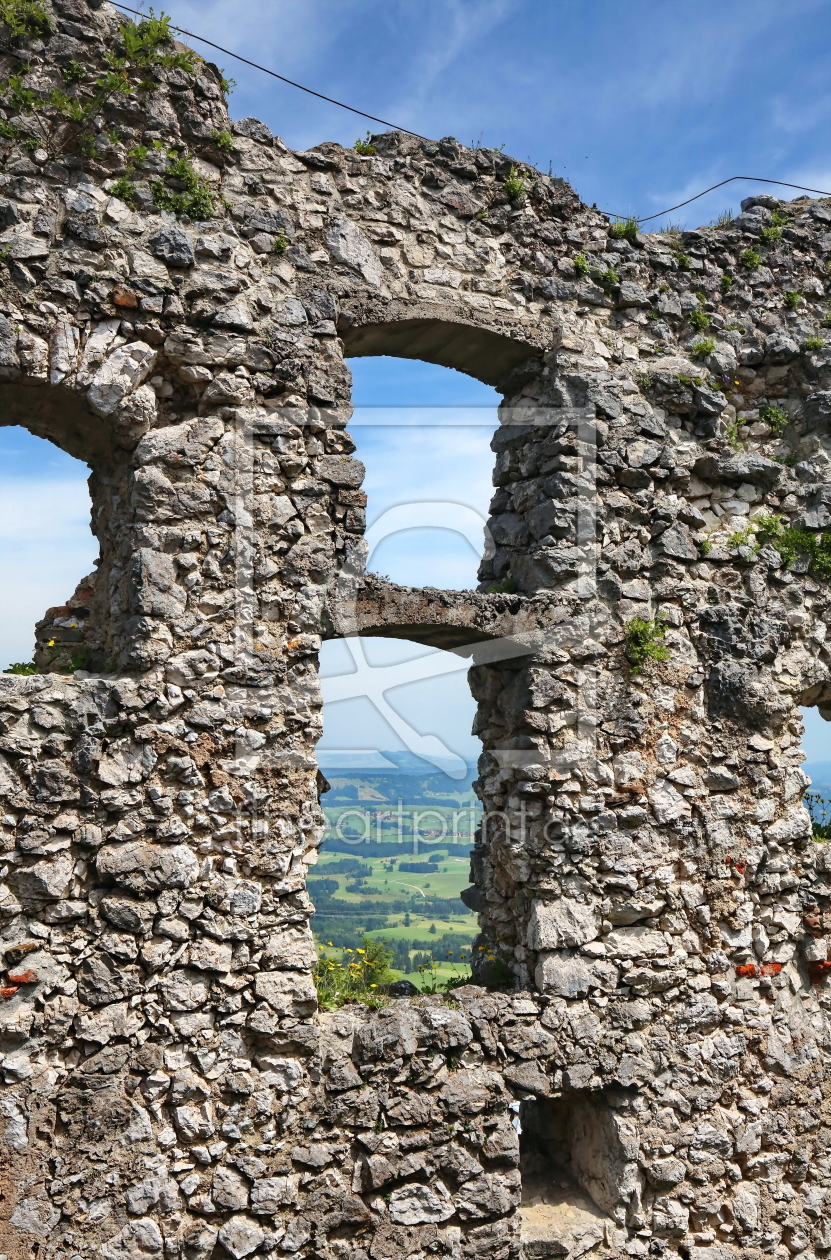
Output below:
[0,0,831,1260]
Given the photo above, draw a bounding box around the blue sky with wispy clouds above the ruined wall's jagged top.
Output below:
[147,0,831,227]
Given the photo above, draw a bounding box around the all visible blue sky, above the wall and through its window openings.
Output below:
[0,0,831,760]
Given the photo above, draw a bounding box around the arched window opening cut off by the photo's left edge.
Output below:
[0,426,98,673]
